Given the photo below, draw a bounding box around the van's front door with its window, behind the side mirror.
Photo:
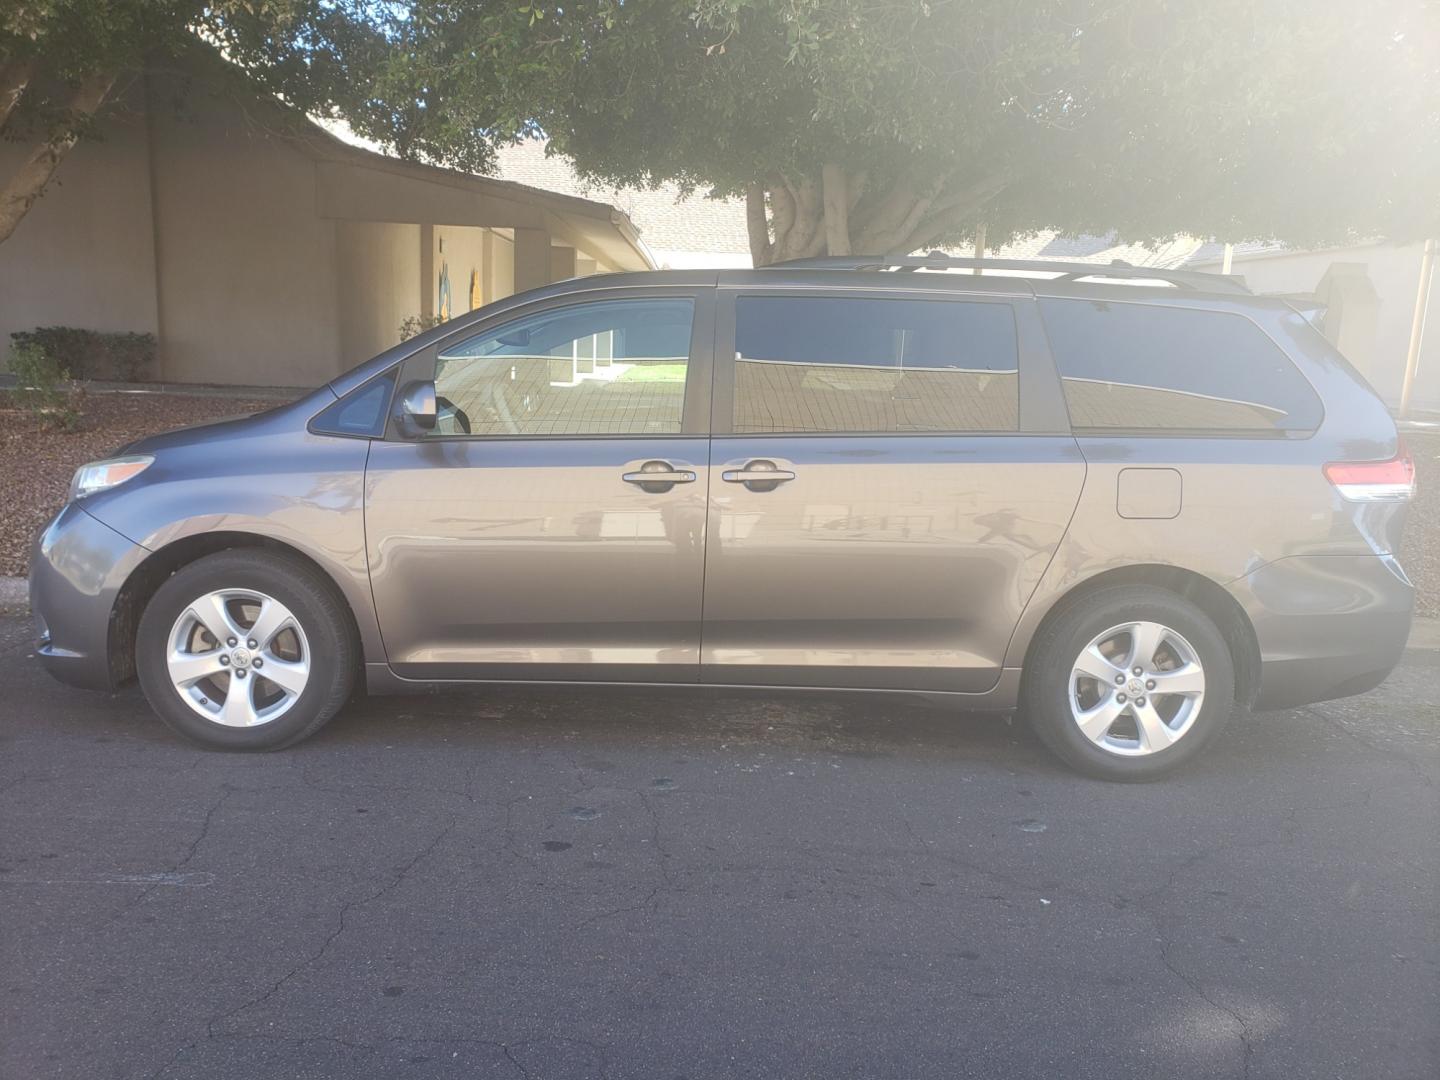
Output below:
[366,289,714,681]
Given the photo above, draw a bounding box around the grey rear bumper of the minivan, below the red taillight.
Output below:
[1227,554,1416,708]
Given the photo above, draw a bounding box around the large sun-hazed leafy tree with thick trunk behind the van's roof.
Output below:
[233,0,1440,264]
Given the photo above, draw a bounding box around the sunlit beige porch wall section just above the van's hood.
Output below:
[336,222,420,370]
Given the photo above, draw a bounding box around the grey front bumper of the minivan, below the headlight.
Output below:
[30,503,150,690]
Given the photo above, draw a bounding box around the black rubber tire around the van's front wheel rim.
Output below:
[135,549,359,750]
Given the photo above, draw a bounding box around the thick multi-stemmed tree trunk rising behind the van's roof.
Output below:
[746,163,1009,266]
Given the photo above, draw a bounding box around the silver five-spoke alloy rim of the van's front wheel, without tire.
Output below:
[166,589,310,727]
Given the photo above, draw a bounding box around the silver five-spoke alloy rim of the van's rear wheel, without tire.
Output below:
[1070,622,1205,757]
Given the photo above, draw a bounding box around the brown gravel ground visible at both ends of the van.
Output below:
[0,392,1440,616]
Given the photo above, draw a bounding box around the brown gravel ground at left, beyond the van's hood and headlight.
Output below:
[0,393,275,576]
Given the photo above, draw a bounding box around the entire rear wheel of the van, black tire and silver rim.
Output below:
[1021,586,1236,780]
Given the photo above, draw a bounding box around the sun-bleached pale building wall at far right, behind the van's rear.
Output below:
[1221,243,1440,409]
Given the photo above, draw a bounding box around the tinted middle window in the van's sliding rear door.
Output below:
[734,297,1020,432]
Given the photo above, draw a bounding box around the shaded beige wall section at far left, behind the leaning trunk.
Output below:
[0,92,158,364]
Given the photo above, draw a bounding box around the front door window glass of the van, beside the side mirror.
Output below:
[432,298,694,435]
